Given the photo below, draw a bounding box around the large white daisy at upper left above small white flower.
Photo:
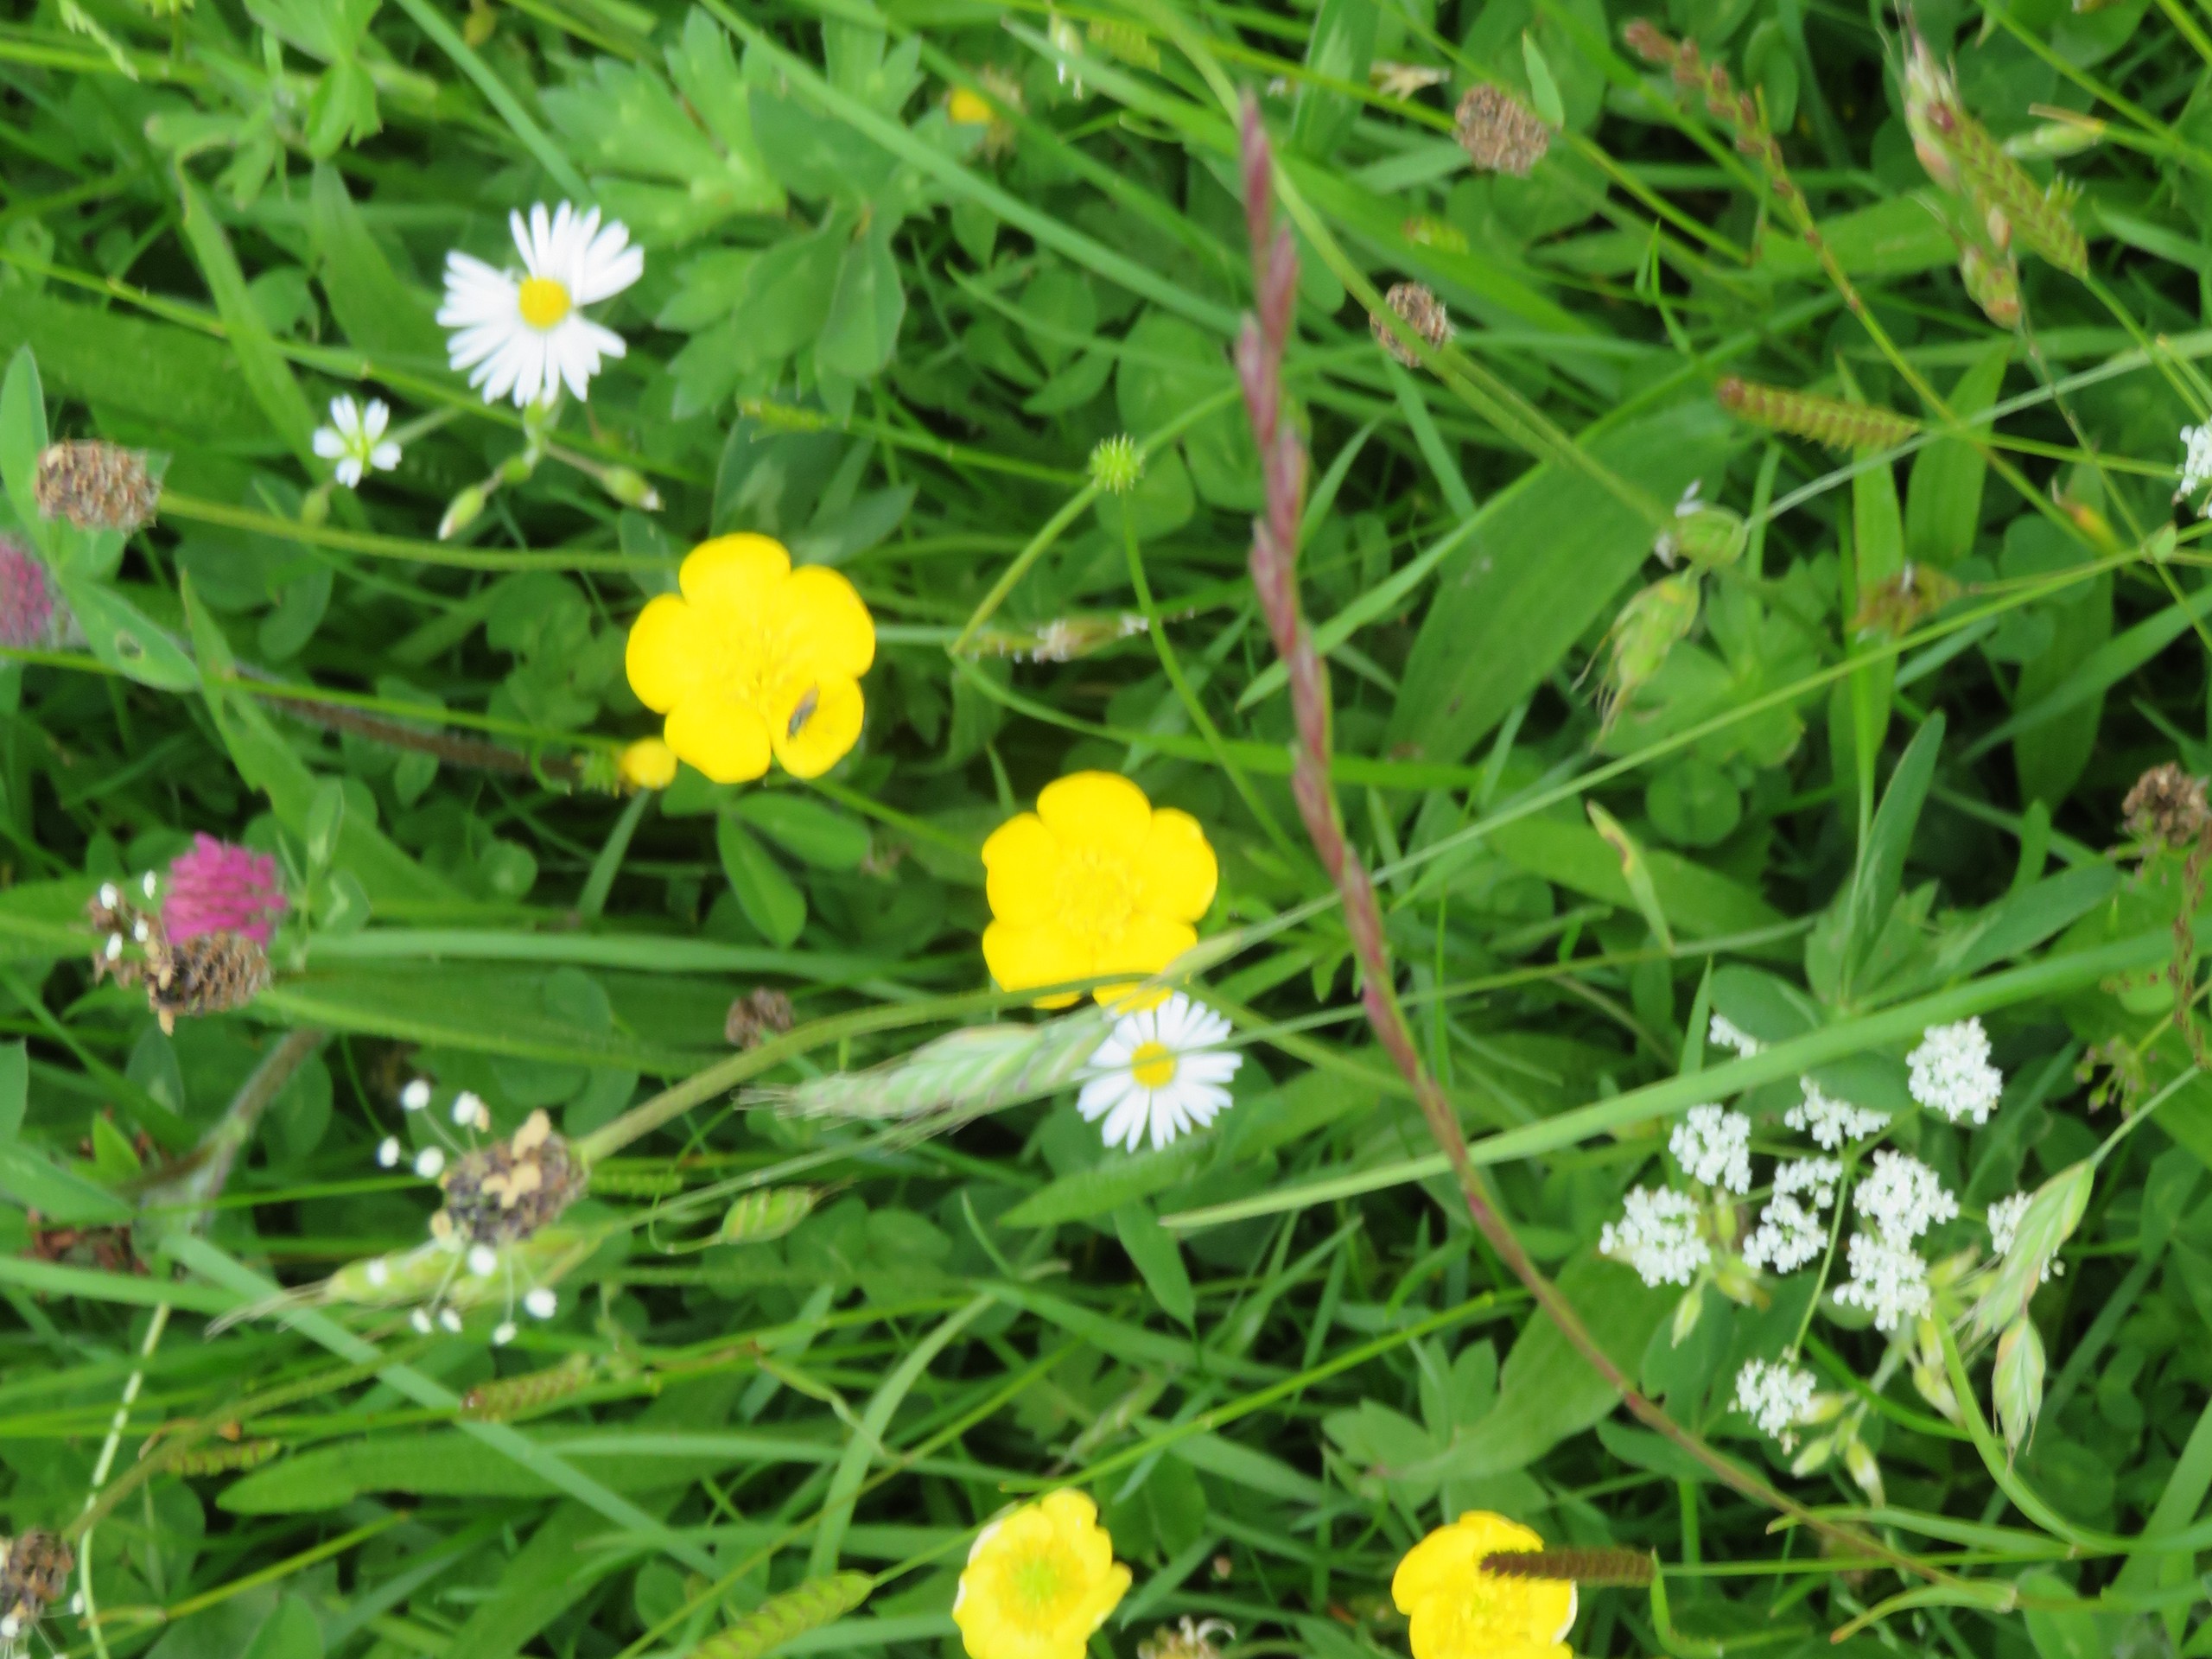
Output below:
[438,201,646,407]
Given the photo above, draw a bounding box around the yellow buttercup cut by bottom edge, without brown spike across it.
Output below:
[953,1491,1128,1659]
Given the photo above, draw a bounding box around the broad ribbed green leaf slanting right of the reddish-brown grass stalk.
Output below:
[1385,403,1741,765]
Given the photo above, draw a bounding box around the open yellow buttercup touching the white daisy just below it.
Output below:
[982,772,1221,1008]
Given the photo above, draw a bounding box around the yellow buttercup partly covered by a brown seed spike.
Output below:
[1389,1509,1575,1659]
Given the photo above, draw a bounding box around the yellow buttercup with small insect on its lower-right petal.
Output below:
[624,536,876,783]
